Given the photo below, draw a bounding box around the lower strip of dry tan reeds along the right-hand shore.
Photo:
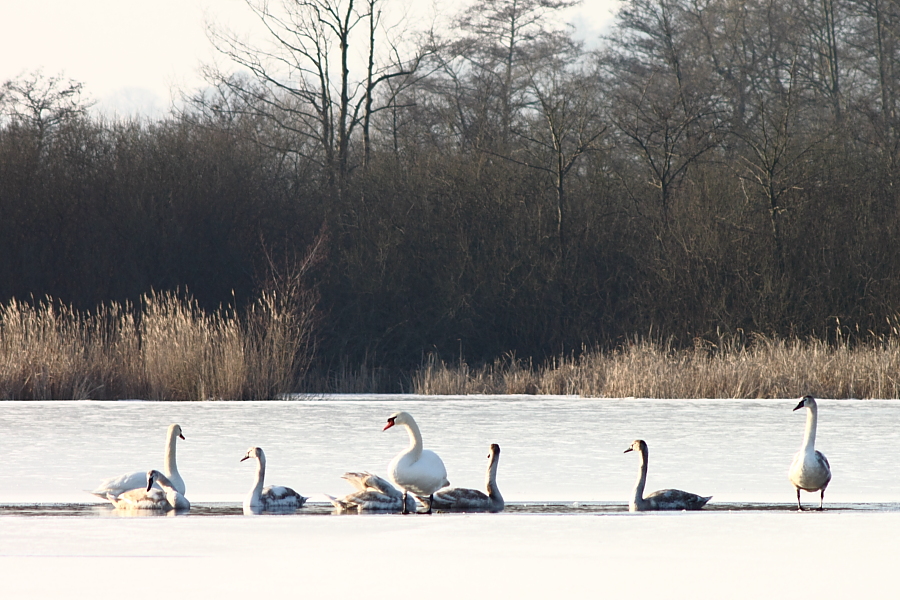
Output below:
[412,335,900,398]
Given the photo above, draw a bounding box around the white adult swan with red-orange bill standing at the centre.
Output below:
[382,410,450,514]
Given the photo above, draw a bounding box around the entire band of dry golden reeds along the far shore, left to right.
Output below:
[7,291,900,400]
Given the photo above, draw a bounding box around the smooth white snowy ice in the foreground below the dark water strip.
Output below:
[0,512,900,599]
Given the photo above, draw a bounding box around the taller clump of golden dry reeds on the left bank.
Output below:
[0,290,312,400]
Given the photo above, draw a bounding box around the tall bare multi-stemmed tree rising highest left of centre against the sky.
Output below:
[206,0,421,193]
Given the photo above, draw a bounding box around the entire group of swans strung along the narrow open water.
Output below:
[82,395,832,514]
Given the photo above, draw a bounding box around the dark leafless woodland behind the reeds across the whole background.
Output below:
[0,0,900,389]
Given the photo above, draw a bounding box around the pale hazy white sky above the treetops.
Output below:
[0,0,618,115]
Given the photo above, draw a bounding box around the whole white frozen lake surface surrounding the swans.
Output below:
[0,396,900,598]
